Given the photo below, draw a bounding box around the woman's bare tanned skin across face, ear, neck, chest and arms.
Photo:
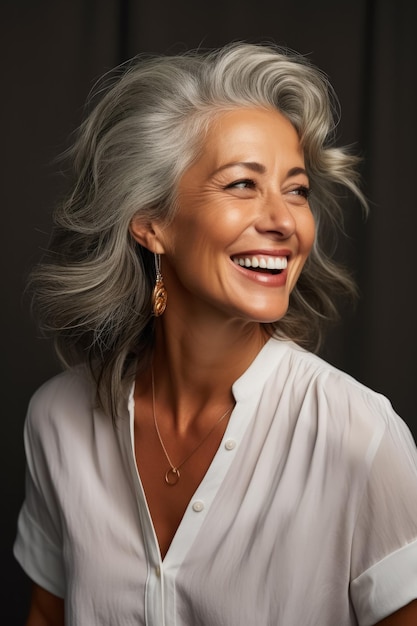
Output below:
[27,109,417,626]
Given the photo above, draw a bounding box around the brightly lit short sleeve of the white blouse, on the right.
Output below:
[351,403,417,626]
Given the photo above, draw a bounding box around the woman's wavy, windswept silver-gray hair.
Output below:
[31,43,366,418]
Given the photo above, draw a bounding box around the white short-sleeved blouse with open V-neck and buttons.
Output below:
[14,339,417,626]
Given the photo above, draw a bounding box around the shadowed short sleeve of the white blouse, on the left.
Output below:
[14,392,65,597]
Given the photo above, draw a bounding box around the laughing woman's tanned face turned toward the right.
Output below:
[154,108,315,323]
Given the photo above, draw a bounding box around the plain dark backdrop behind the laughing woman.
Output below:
[0,0,417,626]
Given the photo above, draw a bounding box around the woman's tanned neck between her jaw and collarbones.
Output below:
[149,315,268,429]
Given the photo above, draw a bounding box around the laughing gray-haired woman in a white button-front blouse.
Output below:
[15,44,417,626]
